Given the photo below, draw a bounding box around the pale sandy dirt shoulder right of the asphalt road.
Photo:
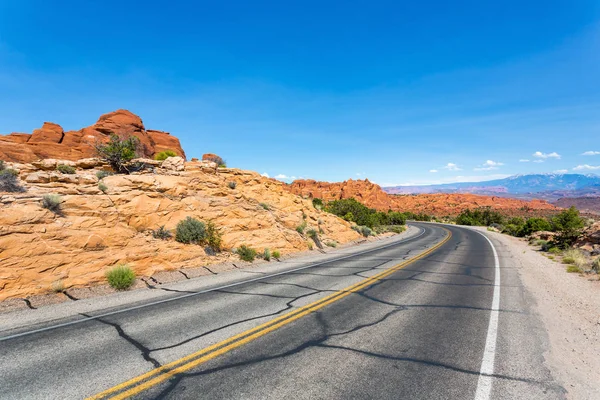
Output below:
[478,228,600,399]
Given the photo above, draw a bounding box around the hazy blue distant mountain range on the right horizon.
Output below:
[383,174,600,200]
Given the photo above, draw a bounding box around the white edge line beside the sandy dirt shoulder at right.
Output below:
[473,230,500,400]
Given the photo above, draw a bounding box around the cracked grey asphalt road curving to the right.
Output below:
[0,224,565,399]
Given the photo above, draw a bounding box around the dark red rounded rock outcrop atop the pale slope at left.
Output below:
[0,110,185,163]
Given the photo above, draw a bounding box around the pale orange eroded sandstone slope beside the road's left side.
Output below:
[0,165,359,300]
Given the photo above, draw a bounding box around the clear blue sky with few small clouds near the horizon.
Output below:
[0,0,600,185]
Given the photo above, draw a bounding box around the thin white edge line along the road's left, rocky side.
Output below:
[0,228,432,342]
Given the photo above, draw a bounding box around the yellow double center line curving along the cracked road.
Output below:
[88,229,452,400]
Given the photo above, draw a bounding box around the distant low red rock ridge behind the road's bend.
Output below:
[287,179,559,217]
